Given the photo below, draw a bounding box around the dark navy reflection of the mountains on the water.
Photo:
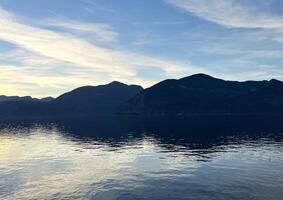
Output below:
[3,116,283,148]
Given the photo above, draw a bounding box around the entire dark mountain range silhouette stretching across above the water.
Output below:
[0,74,283,117]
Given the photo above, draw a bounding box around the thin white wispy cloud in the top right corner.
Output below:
[165,0,283,29]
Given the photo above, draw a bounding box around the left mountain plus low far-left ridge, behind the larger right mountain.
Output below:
[0,81,143,117]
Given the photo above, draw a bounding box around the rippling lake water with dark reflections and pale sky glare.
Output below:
[0,115,283,200]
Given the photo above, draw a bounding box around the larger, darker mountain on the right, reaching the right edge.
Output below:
[119,74,283,115]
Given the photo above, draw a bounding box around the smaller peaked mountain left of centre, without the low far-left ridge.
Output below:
[49,81,143,114]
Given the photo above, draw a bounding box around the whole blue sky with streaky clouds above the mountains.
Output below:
[0,0,283,97]
